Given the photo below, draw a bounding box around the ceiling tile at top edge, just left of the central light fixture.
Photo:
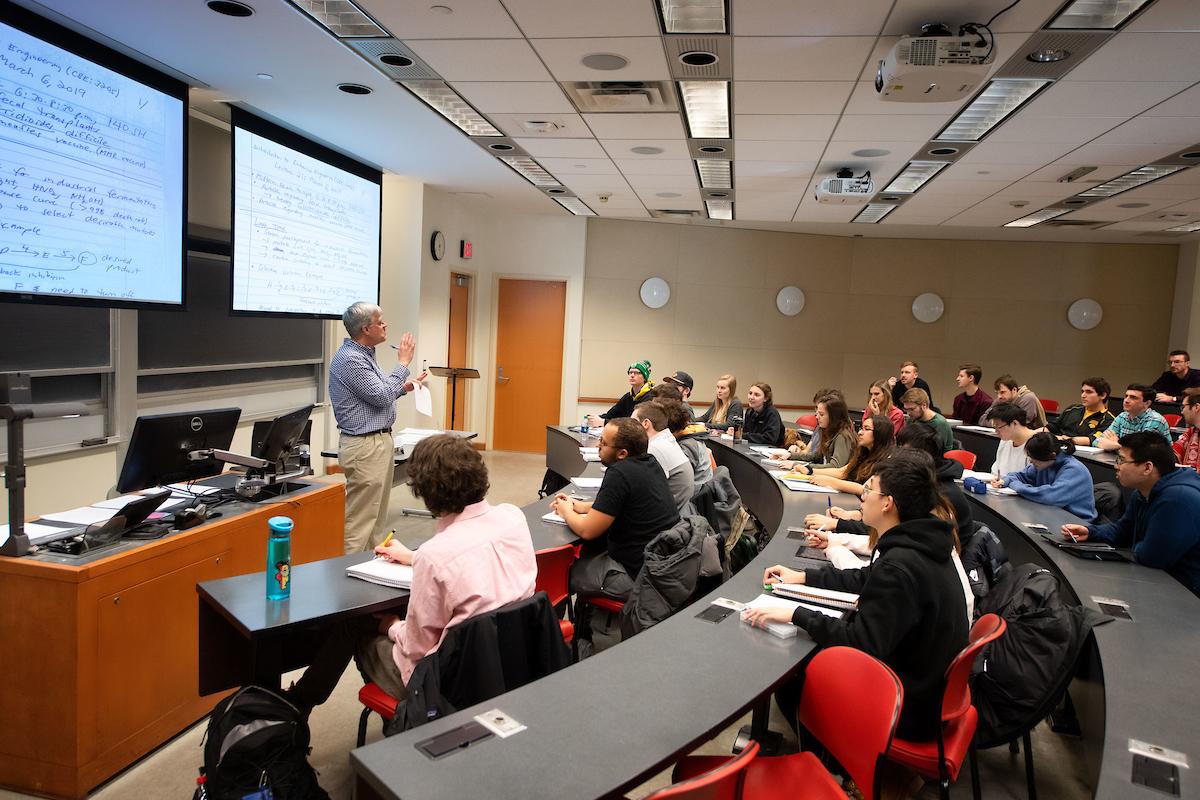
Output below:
[501,0,660,38]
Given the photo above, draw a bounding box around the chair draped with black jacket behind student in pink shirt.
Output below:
[358,591,571,747]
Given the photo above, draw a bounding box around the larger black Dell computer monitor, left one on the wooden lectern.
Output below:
[116,408,241,493]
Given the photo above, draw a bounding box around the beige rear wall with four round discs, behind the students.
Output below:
[580,219,1178,419]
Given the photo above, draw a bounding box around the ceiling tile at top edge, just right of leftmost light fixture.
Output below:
[359,0,521,41]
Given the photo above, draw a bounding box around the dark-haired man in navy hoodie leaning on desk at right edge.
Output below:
[1062,431,1200,595]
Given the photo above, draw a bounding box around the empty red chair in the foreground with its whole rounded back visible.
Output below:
[673,646,904,800]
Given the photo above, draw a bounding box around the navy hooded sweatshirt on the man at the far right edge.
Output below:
[1087,469,1200,595]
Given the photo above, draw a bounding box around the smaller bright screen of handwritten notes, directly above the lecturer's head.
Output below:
[233,127,380,317]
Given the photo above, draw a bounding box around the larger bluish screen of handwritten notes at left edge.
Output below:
[0,23,184,305]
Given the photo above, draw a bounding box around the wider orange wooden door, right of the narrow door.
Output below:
[491,281,566,453]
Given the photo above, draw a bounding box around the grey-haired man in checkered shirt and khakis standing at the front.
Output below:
[329,302,425,554]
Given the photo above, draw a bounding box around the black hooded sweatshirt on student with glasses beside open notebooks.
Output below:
[792,517,968,741]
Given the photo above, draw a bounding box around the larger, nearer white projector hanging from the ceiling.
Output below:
[875,36,995,103]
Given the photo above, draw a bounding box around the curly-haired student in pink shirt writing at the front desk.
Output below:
[288,434,538,708]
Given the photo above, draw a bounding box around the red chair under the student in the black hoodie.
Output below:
[888,614,1007,800]
